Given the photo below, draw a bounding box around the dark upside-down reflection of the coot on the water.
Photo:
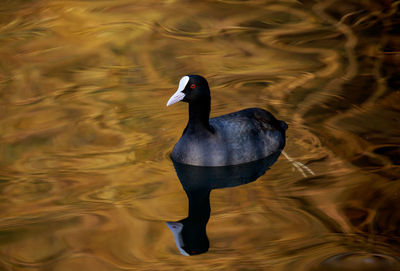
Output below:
[167,152,280,256]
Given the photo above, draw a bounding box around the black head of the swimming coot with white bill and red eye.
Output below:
[167,75,210,106]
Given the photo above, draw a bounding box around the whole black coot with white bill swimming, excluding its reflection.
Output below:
[167,75,287,166]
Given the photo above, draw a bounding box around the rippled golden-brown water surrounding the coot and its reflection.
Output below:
[0,0,400,271]
